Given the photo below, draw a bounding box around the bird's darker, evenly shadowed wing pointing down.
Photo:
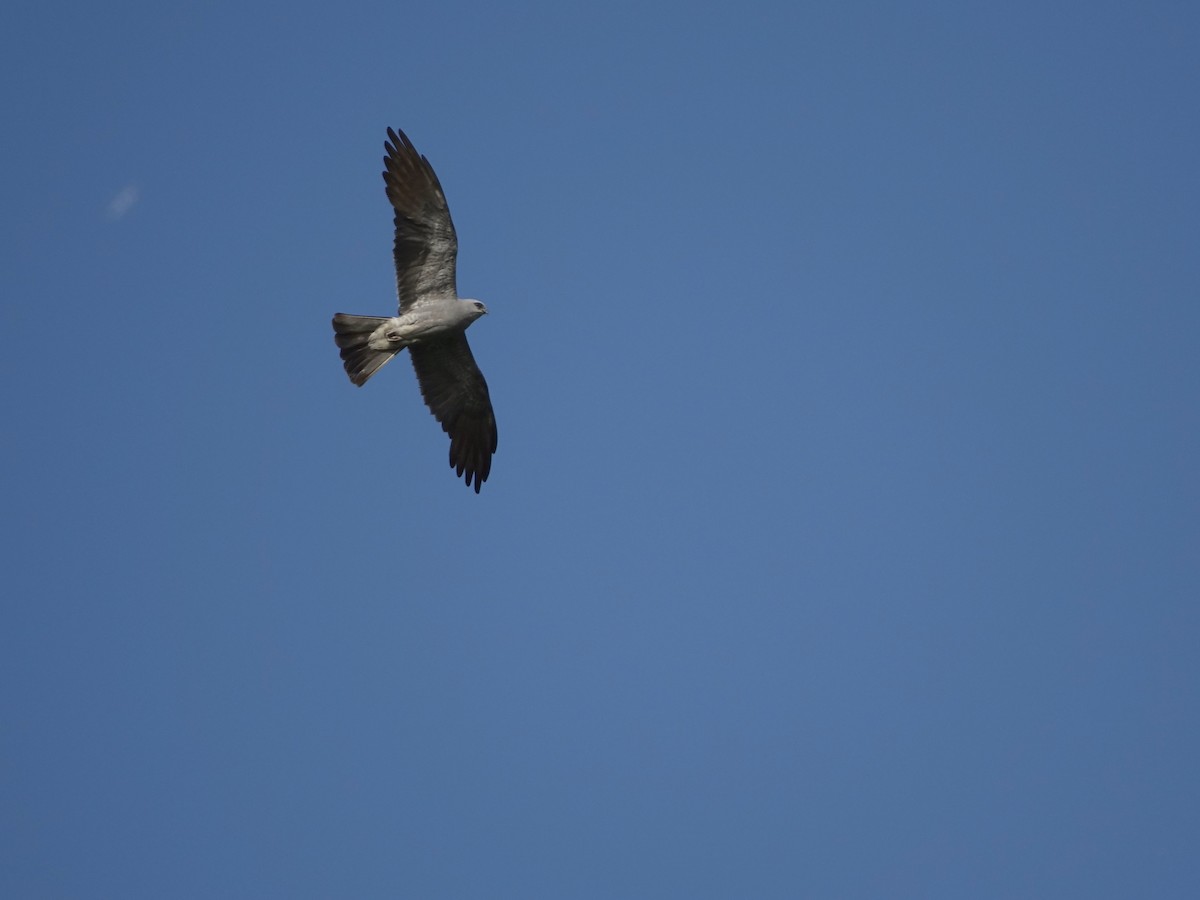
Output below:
[408,332,497,493]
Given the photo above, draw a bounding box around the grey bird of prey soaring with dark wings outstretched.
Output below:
[334,128,497,493]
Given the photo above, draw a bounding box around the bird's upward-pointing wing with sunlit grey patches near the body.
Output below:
[383,128,458,312]
